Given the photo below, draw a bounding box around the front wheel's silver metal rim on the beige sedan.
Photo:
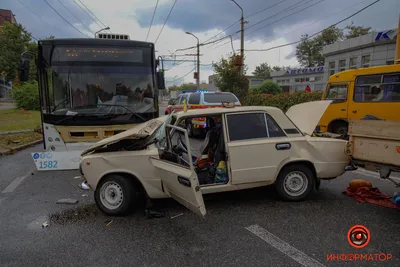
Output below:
[100,182,124,210]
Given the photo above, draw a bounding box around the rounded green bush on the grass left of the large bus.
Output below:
[12,81,40,110]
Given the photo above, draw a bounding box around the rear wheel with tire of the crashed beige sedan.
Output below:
[275,164,315,201]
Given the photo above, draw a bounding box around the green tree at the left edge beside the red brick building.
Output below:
[0,22,31,80]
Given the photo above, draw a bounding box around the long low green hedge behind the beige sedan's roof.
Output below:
[241,92,322,112]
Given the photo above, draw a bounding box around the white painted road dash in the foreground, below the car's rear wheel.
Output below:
[246,224,325,267]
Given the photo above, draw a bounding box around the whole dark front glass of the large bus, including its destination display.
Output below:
[39,45,157,122]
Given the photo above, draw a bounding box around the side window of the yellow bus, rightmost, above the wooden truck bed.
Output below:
[354,73,400,102]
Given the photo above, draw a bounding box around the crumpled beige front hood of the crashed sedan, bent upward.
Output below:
[81,116,167,156]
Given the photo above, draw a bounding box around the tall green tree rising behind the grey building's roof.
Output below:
[296,26,343,67]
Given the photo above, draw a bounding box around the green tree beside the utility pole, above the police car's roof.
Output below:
[213,57,249,97]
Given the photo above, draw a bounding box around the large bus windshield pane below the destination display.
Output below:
[50,65,154,115]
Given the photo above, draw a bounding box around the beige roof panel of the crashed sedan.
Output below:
[176,106,282,118]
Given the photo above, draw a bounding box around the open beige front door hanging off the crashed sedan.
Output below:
[150,125,206,219]
